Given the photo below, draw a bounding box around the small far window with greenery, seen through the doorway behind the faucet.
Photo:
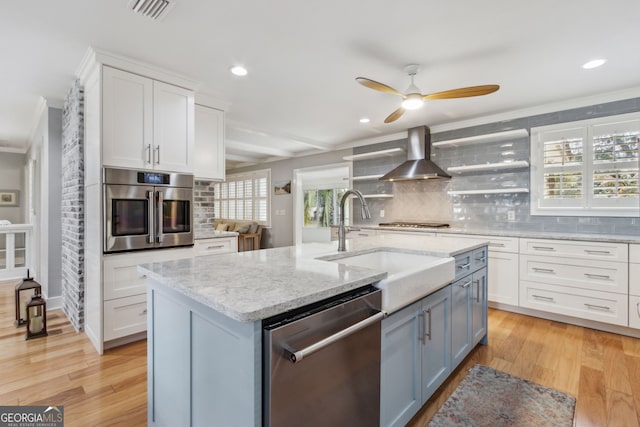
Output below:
[304,188,349,227]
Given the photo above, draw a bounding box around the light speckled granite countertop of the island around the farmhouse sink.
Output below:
[138,235,487,322]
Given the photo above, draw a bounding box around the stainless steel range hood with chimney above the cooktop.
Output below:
[380,126,451,181]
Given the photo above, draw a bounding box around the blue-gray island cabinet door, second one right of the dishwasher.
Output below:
[420,285,451,406]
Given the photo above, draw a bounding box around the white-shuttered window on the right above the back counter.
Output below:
[531,113,640,216]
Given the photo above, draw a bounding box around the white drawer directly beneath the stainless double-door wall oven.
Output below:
[102,248,193,300]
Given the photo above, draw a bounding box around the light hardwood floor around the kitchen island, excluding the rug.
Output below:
[0,282,640,427]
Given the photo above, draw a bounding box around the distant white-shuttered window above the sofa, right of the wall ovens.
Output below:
[213,169,271,227]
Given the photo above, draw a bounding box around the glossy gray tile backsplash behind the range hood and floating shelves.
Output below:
[353,98,640,235]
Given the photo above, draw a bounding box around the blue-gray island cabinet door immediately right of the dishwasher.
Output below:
[380,301,422,427]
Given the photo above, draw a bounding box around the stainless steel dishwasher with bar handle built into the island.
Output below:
[263,286,384,427]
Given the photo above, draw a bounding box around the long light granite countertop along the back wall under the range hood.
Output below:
[353,224,640,243]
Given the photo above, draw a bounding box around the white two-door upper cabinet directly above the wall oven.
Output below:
[102,66,194,173]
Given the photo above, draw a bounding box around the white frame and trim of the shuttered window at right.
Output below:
[530,112,640,217]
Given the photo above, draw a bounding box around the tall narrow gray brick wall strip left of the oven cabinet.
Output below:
[61,80,84,331]
